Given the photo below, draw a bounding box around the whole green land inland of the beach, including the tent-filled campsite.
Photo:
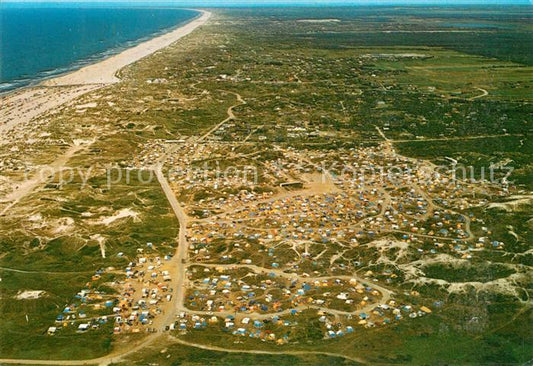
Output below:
[0,7,533,365]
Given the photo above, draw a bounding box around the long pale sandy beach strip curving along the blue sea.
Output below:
[0,11,211,137]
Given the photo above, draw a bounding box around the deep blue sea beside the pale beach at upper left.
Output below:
[0,6,199,92]
